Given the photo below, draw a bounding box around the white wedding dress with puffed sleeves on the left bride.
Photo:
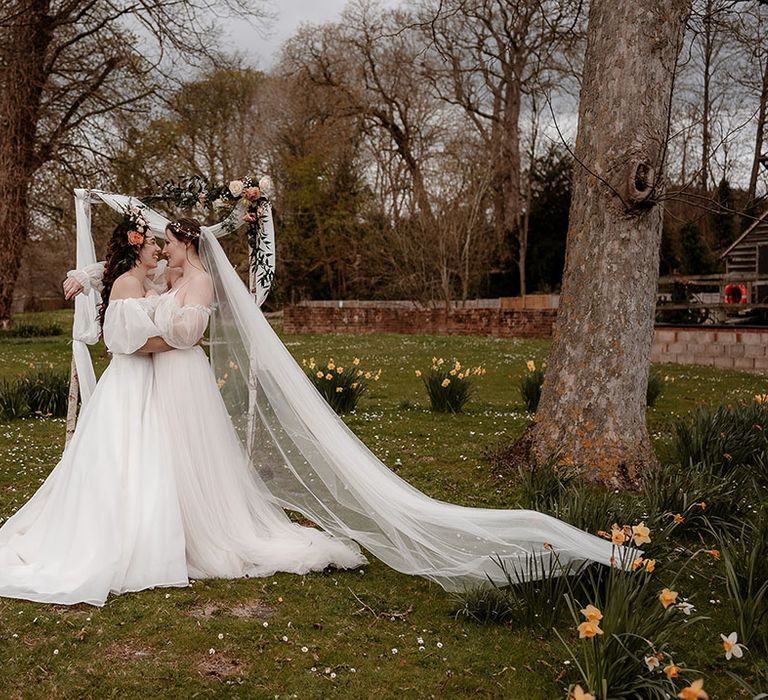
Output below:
[0,299,188,605]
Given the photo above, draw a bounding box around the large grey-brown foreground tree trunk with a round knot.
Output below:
[534,0,690,487]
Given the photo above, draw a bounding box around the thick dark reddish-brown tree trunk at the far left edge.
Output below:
[0,0,52,328]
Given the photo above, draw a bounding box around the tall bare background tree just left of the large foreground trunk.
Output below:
[422,0,581,294]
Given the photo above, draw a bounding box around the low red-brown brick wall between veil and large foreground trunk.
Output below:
[283,302,557,338]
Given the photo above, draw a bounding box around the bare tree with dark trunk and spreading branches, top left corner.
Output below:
[0,0,270,327]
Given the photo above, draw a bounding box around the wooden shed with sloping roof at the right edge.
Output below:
[720,210,768,304]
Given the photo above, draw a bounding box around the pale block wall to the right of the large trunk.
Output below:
[651,326,768,371]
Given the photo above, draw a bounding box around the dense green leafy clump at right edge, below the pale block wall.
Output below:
[675,401,768,472]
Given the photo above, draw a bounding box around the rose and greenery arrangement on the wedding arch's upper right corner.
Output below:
[153,175,274,286]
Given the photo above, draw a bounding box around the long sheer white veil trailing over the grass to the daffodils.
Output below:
[72,193,615,590]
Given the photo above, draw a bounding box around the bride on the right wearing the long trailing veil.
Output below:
[54,192,621,590]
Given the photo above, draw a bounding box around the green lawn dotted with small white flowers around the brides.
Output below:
[0,312,768,700]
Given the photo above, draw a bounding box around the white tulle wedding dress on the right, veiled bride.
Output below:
[154,283,366,578]
